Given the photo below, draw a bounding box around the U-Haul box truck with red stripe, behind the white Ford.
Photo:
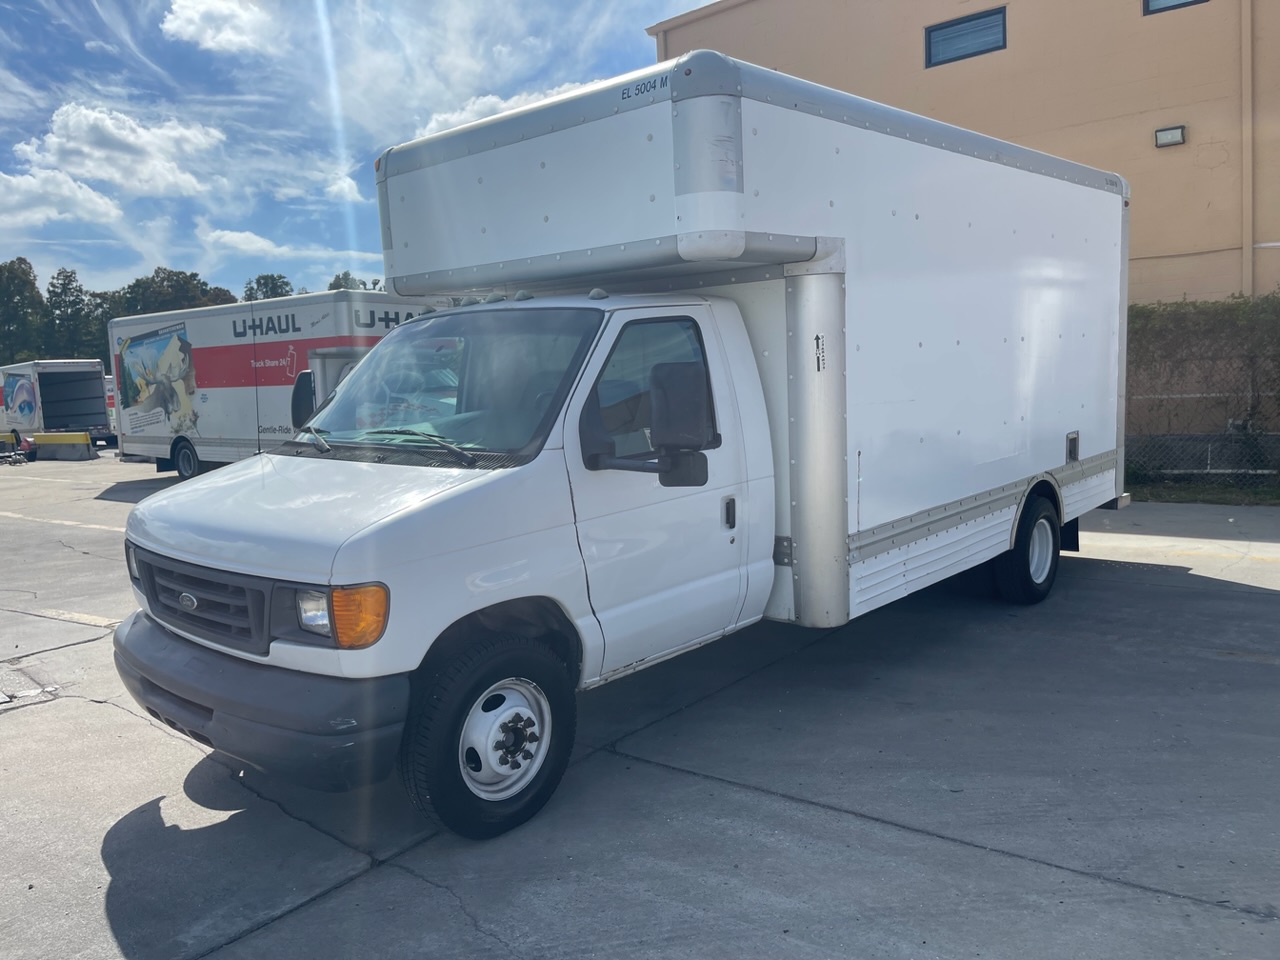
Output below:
[108,291,424,480]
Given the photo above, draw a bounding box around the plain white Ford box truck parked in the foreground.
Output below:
[115,51,1126,837]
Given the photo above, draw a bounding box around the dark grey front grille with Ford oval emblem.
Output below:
[136,550,271,654]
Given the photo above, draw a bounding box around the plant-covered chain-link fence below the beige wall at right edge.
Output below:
[1125,293,1280,488]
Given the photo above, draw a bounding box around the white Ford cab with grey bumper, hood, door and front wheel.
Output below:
[116,292,773,835]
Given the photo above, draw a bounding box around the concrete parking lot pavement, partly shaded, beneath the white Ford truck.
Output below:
[0,457,1280,960]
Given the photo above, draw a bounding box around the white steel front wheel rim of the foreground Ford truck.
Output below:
[458,677,552,801]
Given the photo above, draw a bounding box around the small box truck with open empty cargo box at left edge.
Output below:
[0,360,114,445]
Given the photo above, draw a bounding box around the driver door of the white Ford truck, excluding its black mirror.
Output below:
[564,306,749,673]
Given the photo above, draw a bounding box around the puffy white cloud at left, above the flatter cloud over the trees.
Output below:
[13,102,225,196]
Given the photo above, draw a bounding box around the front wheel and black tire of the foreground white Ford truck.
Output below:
[401,636,577,840]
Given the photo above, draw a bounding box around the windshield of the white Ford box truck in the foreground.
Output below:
[296,307,603,466]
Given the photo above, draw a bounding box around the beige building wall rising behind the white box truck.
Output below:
[649,0,1280,301]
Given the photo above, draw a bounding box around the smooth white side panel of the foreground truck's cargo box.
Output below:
[744,101,1124,522]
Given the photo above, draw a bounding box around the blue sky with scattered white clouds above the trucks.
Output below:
[0,0,700,296]
